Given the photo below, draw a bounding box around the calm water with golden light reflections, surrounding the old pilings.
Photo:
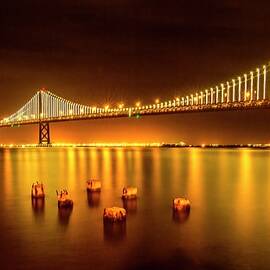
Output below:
[0,148,270,269]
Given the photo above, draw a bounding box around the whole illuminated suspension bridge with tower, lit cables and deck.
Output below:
[0,64,270,145]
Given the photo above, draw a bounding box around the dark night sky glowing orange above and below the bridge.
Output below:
[0,0,270,144]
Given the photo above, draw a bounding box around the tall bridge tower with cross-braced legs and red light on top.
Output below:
[38,90,51,146]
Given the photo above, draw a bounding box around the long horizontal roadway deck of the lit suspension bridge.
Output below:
[0,99,270,127]
